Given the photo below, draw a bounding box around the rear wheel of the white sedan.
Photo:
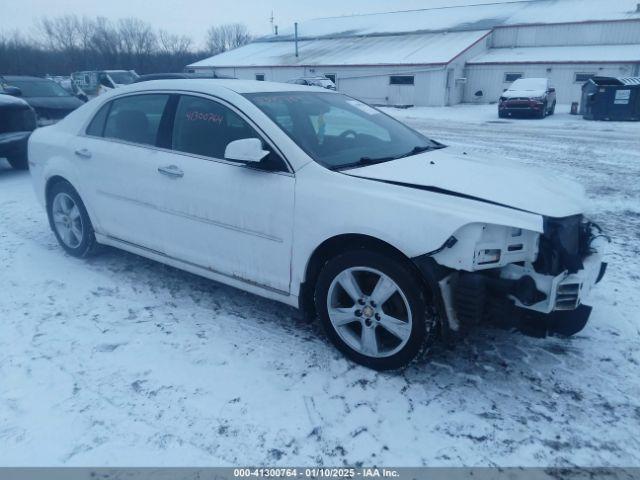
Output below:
[47,181,97,258]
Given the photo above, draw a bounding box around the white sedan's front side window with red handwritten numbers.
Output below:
[172,95,286,171]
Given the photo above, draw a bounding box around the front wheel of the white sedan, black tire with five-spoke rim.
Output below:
[315,250,436,370]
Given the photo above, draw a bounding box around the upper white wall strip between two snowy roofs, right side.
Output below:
[491,20,640,48]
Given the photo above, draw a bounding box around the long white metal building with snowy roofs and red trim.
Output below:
[187,0,640,106]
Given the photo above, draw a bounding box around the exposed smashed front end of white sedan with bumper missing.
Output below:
[422,215,609,336]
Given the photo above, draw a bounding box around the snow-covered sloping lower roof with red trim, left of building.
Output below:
[188,30,490,68]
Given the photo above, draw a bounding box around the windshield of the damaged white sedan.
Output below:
[245,92,443,170]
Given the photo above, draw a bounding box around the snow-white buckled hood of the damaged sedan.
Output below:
[343,147,586,217]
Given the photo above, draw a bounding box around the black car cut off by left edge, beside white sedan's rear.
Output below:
[0,95,36,170]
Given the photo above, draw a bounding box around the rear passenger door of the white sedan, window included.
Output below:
[72,93,170,251]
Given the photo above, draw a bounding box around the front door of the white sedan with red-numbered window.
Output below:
[163,95,295,293]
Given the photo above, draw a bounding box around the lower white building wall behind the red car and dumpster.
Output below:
[464,64,637,103]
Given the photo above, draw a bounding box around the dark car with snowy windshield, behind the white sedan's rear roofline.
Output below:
[0,75,84,127]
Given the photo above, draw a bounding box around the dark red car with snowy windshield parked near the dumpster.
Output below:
[498,78,556,118]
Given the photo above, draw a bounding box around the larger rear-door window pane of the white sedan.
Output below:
[104,94,169,145]
